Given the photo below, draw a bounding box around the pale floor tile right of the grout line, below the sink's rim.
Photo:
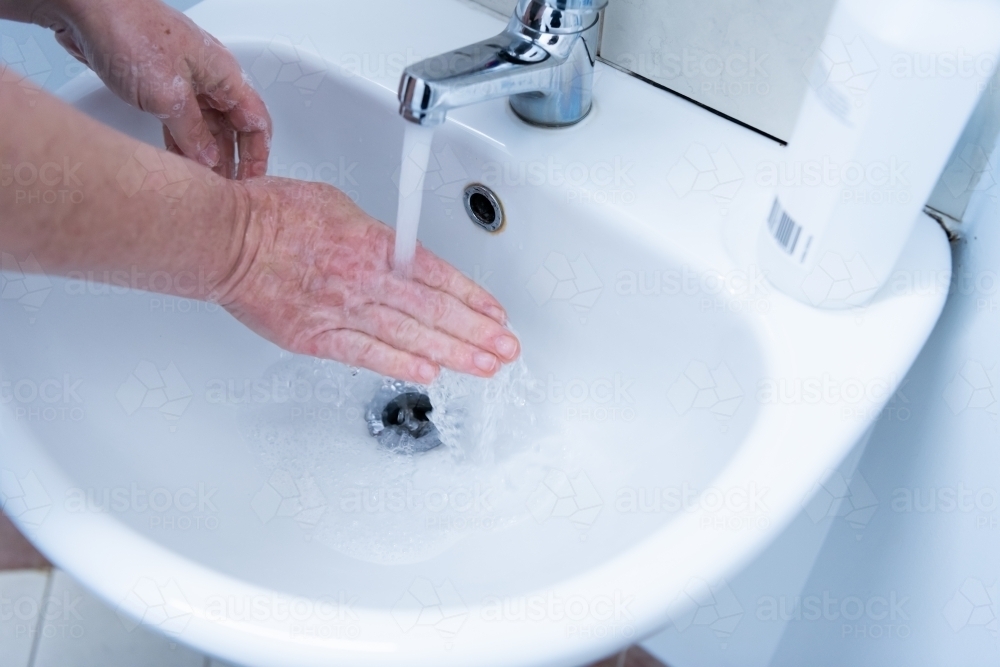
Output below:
[32,570,205,667]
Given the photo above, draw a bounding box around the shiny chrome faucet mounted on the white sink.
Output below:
[399,0,608,127]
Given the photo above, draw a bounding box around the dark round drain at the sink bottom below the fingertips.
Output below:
[365,382,441,454]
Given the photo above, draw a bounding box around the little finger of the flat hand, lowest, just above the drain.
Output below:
[303,329,440,384]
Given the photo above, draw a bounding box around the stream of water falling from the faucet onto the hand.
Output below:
[393,123,434,277]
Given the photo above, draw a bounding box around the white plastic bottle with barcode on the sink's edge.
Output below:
[757,0,1000,308]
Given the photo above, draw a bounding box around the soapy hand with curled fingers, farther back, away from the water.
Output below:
[33,0,271,179]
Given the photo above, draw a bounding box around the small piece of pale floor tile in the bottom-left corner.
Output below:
[0,570,49,667]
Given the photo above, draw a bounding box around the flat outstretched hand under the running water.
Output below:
[215,178,520,384]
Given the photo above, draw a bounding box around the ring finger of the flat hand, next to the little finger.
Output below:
[351,304,500,377]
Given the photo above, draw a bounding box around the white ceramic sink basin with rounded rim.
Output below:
[0,0,950,667]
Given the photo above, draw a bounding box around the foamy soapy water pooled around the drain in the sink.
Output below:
[230,356,562,564]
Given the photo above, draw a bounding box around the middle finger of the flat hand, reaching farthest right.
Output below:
[380,276,521,362]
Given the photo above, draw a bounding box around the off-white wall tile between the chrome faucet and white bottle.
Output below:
[600,0,833,140]
